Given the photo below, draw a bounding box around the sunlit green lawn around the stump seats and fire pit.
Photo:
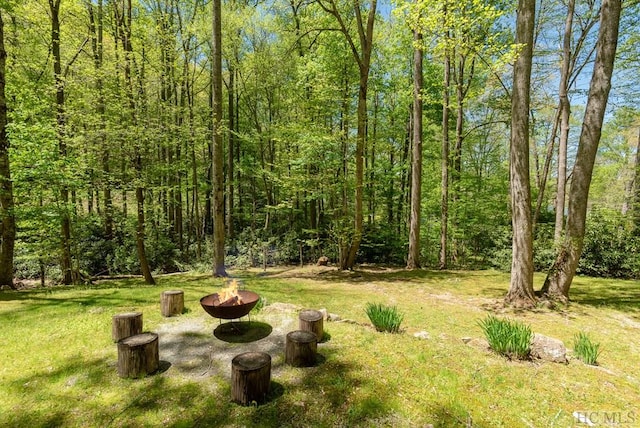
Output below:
[0,267,640,427]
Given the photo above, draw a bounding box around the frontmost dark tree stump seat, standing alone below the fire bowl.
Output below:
[231,352,271,406]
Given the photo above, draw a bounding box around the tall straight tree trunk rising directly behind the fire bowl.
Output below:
[212,0,227,276]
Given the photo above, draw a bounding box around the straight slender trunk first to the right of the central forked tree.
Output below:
[407,31,423,269]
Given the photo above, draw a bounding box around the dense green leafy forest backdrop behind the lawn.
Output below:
[0,0,640,297]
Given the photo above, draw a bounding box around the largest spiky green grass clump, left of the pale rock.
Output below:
[479,315,533,360]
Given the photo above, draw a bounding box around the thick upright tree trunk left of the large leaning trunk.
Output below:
[506,0,536,306]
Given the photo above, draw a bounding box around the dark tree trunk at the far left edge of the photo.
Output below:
[0,11,16,288]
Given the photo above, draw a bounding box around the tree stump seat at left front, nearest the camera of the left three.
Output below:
[118,333,160,377]
